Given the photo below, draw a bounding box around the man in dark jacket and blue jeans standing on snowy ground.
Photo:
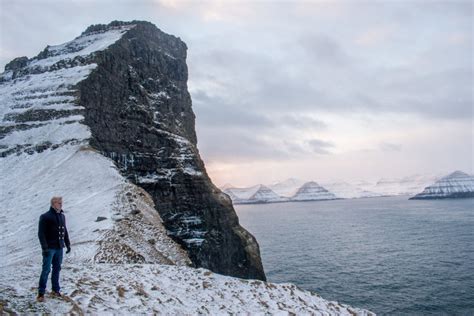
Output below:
[37,196,71,302]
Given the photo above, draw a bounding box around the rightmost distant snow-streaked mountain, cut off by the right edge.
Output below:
[410,171,474,200]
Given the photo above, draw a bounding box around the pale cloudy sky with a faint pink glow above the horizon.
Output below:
[0,0,474,186]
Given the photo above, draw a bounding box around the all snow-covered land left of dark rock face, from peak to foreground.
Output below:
[0,22,370,315]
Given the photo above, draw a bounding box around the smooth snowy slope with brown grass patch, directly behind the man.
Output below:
[0,145,190,267]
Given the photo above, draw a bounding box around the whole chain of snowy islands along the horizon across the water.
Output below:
[221,171,474,204]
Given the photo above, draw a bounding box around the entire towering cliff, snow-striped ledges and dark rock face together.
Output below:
[0,21,265,280]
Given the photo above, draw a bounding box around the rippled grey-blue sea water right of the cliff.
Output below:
[235,197,474,315]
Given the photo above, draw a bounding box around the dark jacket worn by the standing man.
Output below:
[38,207,71,251]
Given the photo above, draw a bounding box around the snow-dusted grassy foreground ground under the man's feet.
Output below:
[0,259,373,316]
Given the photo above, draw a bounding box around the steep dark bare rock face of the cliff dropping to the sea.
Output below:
[76,21,265,280]
